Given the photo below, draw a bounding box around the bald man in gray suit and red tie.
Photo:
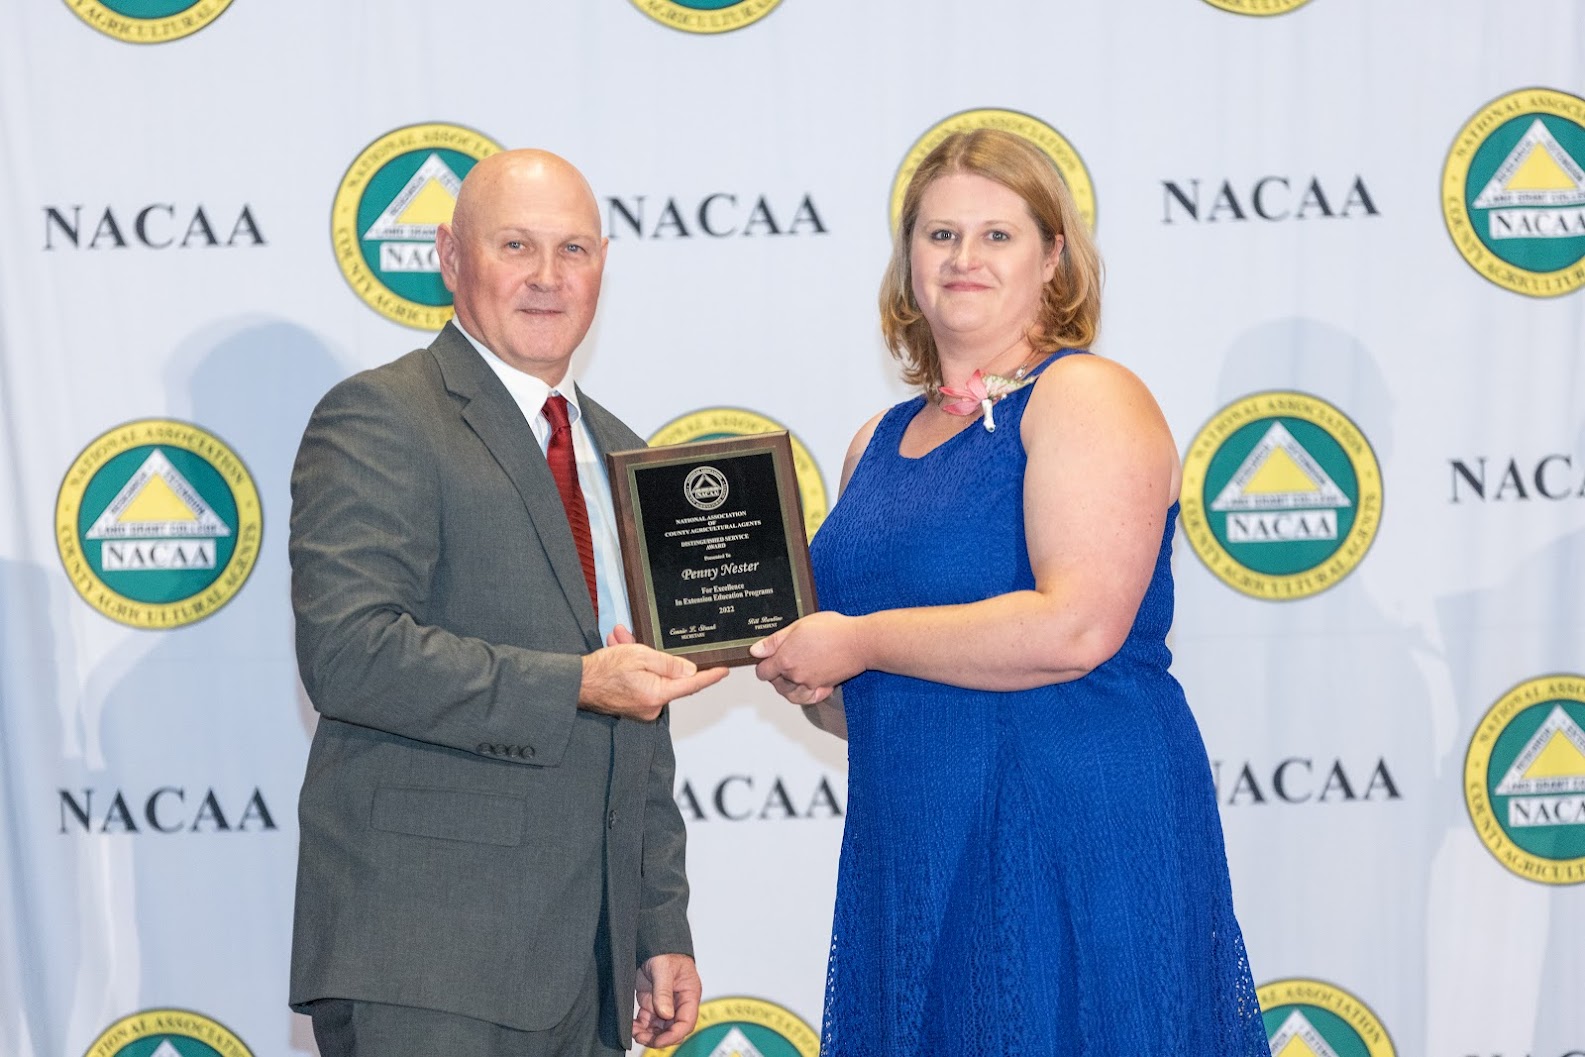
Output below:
[290,151,726,1057]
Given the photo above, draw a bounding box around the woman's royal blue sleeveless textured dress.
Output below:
[812,350,1270,1057]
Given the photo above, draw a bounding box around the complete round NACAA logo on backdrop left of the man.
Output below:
[55,418,265,629]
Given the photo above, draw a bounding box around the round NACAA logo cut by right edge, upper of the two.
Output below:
[1442,89,1585,298]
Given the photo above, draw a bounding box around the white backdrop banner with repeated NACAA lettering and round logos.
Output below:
[0,0,1585,1057]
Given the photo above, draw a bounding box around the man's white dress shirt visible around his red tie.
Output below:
[452,319,632,642]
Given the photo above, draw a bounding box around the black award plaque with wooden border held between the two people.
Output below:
[605,433,816,667]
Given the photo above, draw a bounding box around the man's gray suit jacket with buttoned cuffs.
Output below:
[290,326,693,1041]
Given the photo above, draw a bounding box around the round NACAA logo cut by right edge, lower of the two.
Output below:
[1465,675,1585,884]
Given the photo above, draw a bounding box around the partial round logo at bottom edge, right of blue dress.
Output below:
[1255,979,1398,1057]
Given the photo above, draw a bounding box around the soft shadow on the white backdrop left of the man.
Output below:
[76,319,346,1052]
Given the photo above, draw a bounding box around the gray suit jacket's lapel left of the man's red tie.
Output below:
[430,325,601,650]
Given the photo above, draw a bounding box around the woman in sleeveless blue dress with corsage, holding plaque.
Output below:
[754,130,1268,1057]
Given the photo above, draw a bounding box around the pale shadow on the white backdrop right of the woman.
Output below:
[1174,319,1442,1054]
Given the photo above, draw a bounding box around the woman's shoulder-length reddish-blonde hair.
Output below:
[880,128,1102,390]
